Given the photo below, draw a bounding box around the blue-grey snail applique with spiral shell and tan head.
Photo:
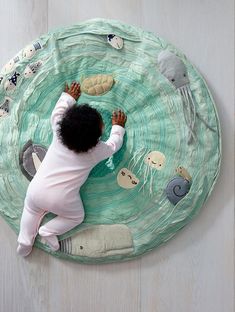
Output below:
[165,166,192,205]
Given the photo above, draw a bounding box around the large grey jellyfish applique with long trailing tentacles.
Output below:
[158,50,215,144]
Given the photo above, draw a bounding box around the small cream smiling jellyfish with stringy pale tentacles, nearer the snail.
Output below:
[128,148,166,196]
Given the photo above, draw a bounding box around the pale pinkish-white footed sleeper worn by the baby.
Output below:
[17,92,125,256]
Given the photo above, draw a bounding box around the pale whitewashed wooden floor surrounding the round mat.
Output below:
[0,0,234,312]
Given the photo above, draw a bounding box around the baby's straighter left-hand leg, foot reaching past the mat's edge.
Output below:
[17,198,47,257]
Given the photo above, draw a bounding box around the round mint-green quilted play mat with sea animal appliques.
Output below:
[0,18,221,263]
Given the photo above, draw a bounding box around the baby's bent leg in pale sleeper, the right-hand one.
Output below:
[38,198,84,251]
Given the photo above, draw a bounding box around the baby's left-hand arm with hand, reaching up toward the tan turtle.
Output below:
[51,82,80,131]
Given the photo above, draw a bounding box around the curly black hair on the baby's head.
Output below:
[57,104,103,153]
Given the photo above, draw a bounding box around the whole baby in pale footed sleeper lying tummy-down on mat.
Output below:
[17,82,127,257]
